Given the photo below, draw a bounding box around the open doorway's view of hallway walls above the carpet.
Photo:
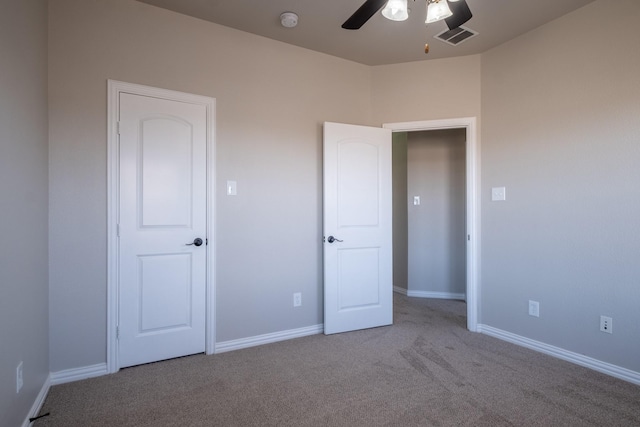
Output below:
[393,129,466,300]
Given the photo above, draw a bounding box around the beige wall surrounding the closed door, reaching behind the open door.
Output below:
[49,0,371,372]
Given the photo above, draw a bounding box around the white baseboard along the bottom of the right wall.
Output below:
[478,324,640,385]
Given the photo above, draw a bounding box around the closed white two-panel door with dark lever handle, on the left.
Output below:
[118,93,207,367]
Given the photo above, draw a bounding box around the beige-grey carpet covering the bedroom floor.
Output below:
[33,294,640,427]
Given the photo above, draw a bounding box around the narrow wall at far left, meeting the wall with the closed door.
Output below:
[0,0,49,426]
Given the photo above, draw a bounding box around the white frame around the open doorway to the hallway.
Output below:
[382,117,480,332]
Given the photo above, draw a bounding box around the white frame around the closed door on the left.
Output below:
[107,80,216,373]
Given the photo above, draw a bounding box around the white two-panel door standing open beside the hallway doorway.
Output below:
[324,123,393,334]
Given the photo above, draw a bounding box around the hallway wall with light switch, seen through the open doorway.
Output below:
[405,129,467,298]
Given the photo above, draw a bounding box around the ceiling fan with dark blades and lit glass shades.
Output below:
[342,0,473,30]
